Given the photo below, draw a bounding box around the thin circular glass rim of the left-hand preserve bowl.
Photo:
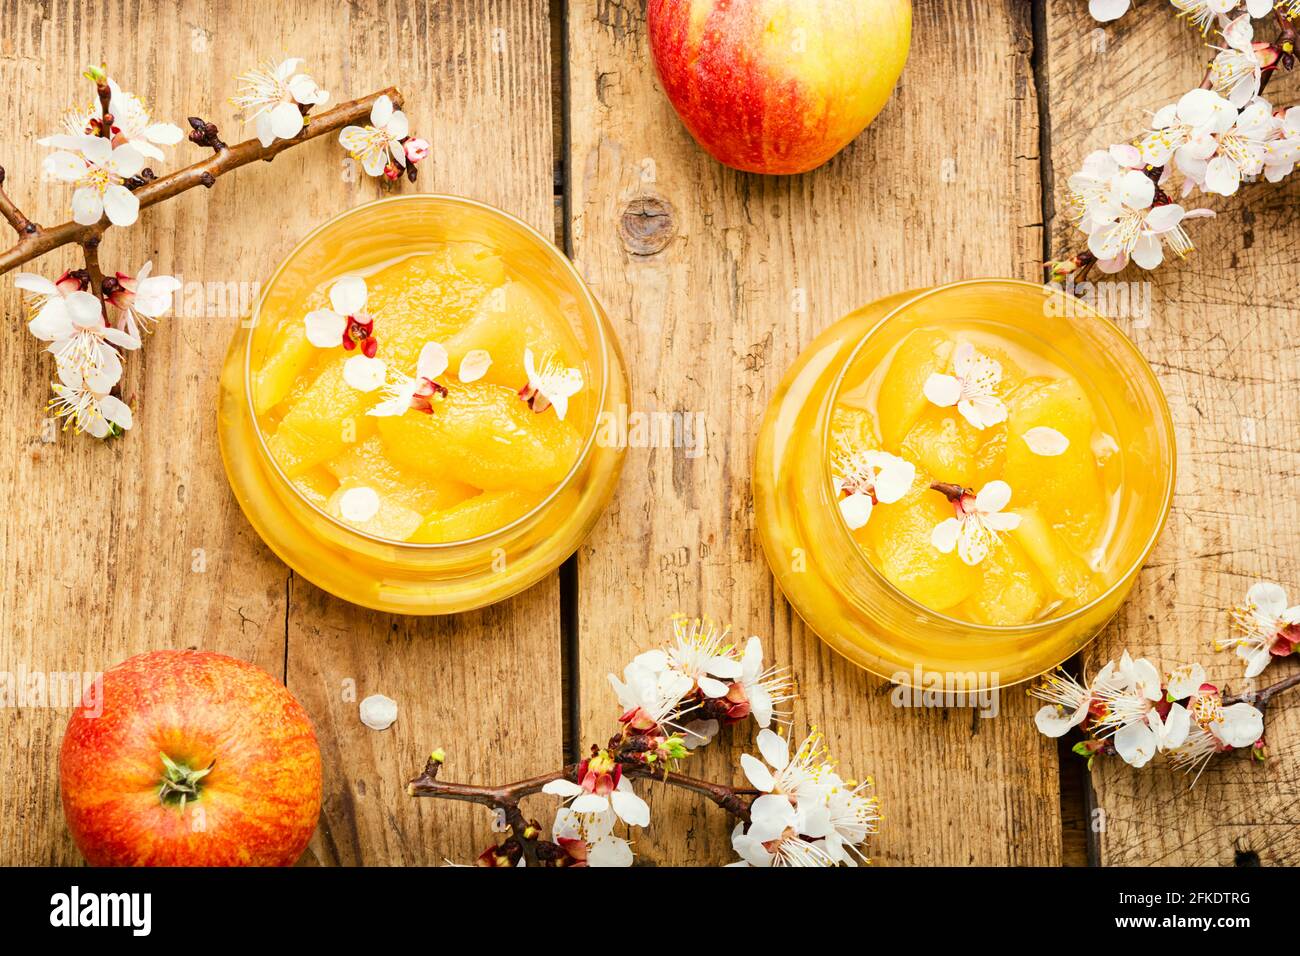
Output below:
[243,193,610,553]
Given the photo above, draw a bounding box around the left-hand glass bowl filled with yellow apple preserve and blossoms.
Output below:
[220,195,627,614]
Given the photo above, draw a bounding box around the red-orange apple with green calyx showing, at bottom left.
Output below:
[59,650,321,866]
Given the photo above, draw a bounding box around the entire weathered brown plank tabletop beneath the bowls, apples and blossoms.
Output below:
[0,0,1300,865]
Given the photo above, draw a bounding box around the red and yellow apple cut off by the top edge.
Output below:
[646,0,911,173]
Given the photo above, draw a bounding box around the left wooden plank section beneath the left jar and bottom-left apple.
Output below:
[0,0,562,864]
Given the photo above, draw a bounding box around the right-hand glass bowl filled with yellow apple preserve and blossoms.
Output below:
[754,280,1175,689]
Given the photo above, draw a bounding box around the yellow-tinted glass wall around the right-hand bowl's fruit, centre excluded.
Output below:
[754,278,1175,691]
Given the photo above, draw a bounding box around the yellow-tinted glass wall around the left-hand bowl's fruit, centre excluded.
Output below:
[217,195,627,614]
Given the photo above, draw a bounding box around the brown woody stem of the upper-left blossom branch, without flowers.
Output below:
[0,87,402,274]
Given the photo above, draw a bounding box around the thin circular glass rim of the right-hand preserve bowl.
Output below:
[820,276,1178,636]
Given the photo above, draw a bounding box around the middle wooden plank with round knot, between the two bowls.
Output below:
[568,0,1061,864]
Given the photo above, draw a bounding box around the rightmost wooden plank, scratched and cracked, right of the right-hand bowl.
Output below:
[1047,0,1300,866]
